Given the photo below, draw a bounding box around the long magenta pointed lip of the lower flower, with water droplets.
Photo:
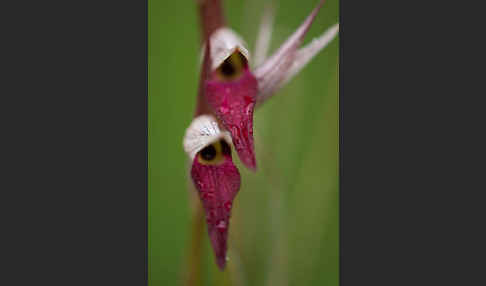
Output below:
[191,155,240,270]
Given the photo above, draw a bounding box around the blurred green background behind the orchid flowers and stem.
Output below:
[148,0,339,286]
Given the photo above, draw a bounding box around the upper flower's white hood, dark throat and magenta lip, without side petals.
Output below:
[200,31,258,170]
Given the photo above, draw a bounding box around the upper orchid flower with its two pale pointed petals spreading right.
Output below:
[200,1,338,170]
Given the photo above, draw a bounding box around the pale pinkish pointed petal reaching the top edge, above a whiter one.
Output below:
[254,0,324,104]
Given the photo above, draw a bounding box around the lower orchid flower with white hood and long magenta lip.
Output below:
[184,115,240,269]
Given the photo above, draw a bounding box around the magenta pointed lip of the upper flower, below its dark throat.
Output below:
[205,69,258,170]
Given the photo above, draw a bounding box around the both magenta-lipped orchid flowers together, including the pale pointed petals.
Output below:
[183,0,339,269]
